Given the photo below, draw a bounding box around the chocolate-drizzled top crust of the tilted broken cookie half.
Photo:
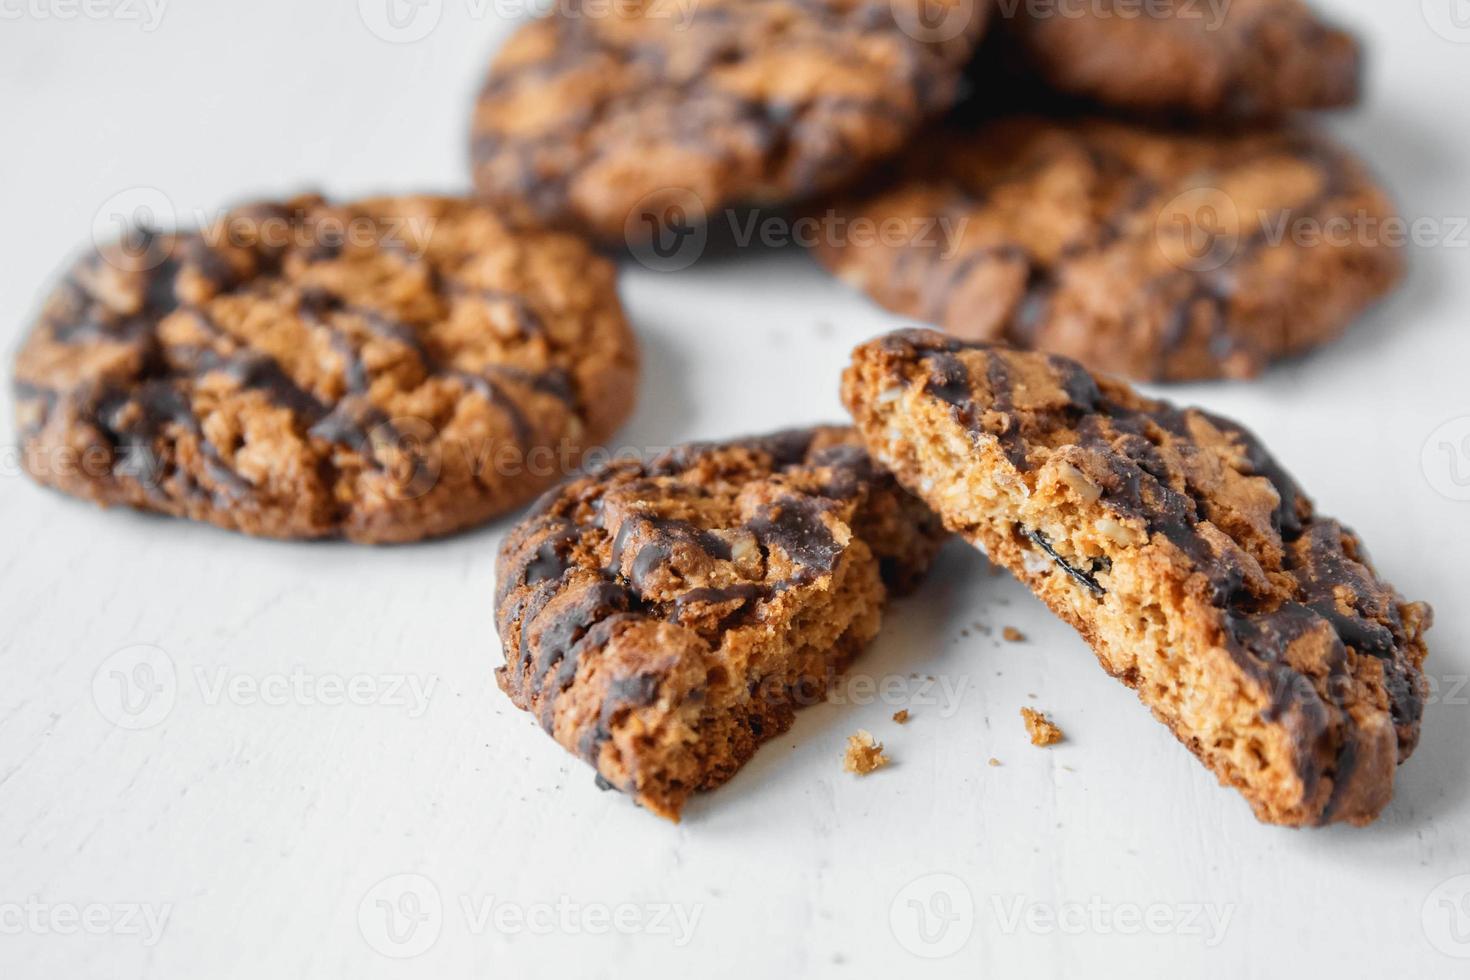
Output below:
[875,331,1427,821]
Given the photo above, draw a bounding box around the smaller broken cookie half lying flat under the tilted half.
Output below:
[495,428,942,820]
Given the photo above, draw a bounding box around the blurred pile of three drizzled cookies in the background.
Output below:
[473,0,1401,381]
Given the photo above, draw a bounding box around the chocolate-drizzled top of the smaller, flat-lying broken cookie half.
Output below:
[497,429,939,789]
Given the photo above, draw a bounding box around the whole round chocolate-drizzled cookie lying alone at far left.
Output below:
[15,197,638,542]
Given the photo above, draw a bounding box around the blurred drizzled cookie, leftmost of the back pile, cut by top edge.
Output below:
[473,0,991,245]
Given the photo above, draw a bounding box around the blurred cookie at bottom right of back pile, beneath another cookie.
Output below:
[816,116,1402,381]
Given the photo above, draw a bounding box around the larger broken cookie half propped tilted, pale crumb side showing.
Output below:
[842,331,1432,826]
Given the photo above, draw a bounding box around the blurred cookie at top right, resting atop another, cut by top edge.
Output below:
[979,0,1363,120]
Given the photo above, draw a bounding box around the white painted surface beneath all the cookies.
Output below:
[0,0,1470,980]
